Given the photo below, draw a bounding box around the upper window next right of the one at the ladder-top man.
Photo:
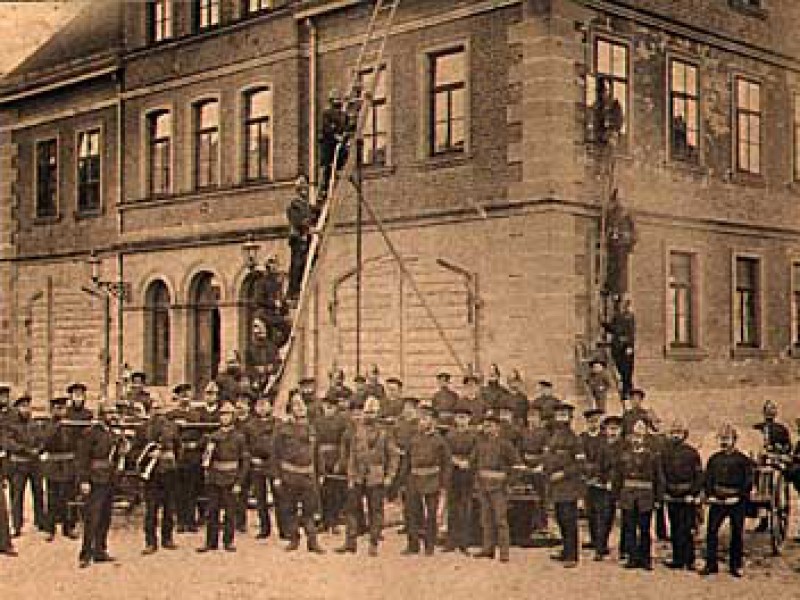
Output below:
[669,60,700,161]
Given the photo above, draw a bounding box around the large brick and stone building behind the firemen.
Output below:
[0,0,800,432]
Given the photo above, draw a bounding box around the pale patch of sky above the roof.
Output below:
[0,0,87,73]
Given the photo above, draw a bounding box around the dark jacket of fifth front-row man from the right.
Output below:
[544,425,585,502]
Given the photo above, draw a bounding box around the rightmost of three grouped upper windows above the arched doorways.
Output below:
[244,88,272,181]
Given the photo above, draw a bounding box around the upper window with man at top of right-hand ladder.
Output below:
[586,38,630,142]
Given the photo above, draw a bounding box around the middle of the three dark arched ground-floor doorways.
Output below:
[188,271,221,390]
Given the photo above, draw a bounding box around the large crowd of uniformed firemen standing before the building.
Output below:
[0,365,790,577]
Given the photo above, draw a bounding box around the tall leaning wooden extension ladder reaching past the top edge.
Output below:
[266,0,400,408]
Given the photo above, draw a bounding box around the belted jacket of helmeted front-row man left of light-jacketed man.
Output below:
[273,420,319,488]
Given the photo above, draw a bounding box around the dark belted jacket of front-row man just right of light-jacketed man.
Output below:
[405,431,452,494]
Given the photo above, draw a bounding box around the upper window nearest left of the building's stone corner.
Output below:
[430,47,467,154]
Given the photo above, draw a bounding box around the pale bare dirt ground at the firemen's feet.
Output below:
[0,500,800,600]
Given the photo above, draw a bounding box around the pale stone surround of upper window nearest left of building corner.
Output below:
[417,38,472,163]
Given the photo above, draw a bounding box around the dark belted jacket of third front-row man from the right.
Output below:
[613,444,664,511]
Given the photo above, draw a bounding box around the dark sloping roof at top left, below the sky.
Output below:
[0,0,124,91]
